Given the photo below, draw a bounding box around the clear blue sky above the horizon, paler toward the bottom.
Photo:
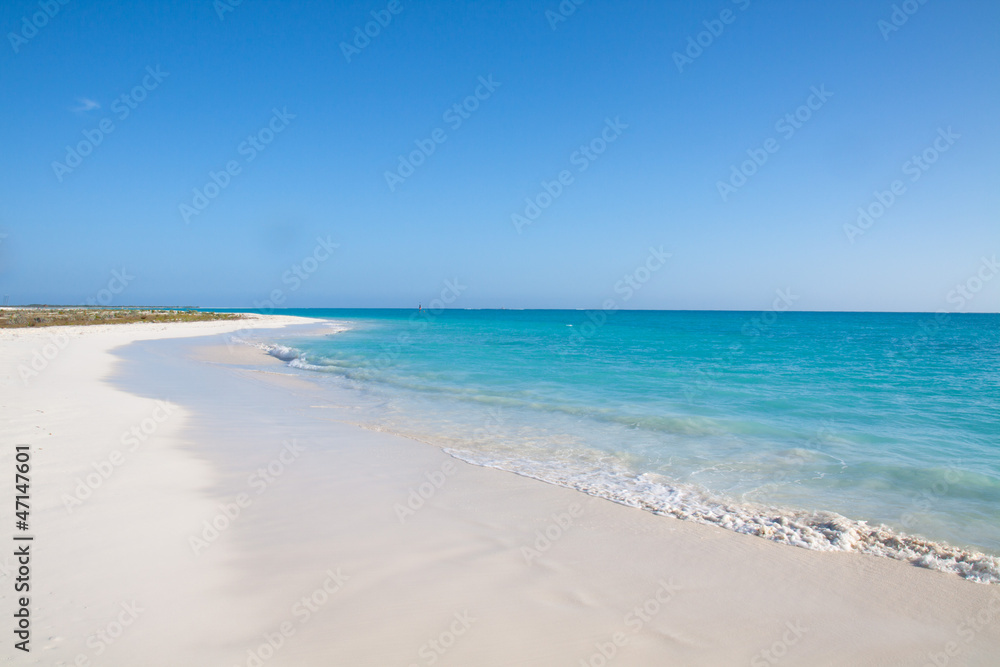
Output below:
[0,0,1000,312]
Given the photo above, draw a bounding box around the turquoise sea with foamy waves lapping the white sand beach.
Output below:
[223,310,1000,583]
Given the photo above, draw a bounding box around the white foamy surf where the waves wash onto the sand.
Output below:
[264,320,1000,584]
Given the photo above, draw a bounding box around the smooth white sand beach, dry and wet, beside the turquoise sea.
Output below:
[0,318,1000,667]
